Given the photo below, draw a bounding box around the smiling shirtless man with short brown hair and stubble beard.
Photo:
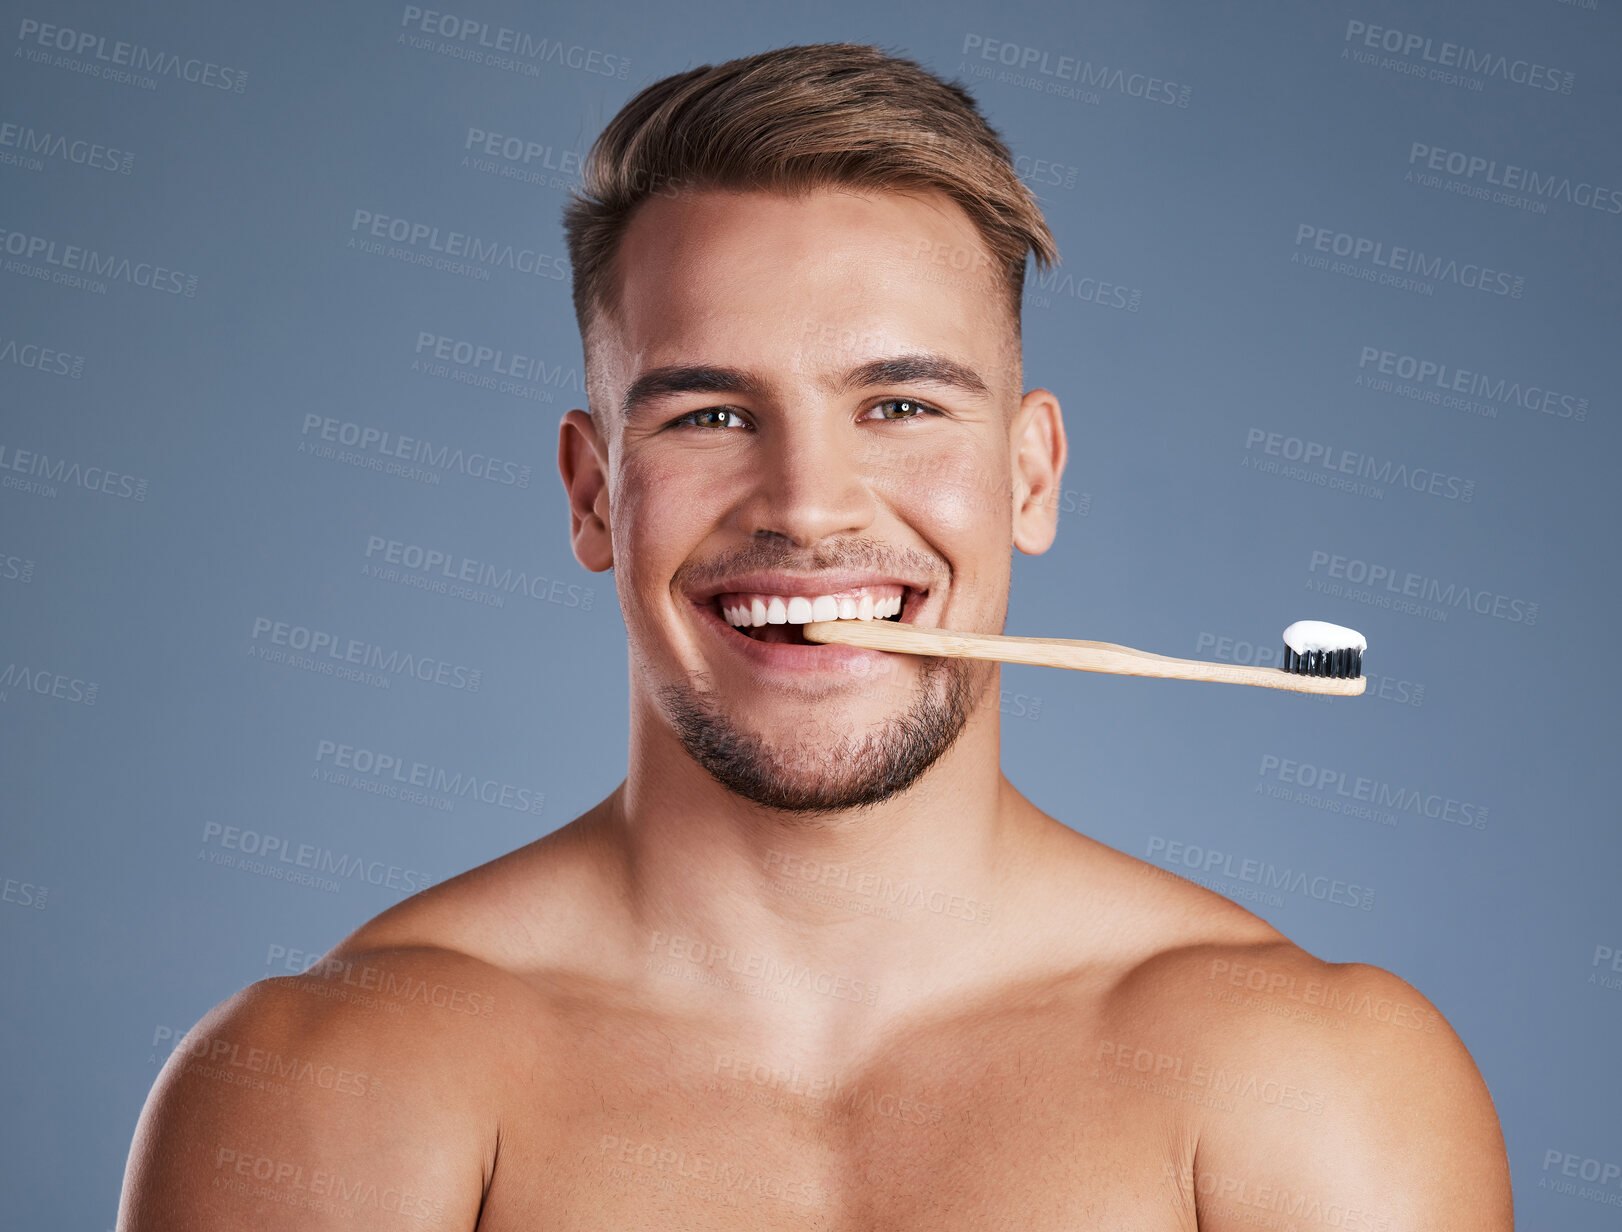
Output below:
[118,45,1512,1232]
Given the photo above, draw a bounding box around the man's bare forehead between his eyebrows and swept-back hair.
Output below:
[603,190,1011,389]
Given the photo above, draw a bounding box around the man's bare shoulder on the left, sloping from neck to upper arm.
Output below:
[118,813,613,1232]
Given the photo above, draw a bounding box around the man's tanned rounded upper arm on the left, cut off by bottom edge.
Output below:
[118,955,506,1232]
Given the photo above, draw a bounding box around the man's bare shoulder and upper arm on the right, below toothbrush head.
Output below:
[1095,861,1513,1232]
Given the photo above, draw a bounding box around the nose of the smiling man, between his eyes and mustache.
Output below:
[738,412,876,548]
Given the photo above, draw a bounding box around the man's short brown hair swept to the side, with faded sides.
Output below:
[563,42,1059,356]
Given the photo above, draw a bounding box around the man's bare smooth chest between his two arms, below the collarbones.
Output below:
[478,1033,1194,1232]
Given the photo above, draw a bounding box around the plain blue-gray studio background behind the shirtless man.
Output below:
[0,0,1622,1229]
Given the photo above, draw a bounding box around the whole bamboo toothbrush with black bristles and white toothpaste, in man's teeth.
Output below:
[803,621,1369,697]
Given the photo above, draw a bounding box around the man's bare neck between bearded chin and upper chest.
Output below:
[605,678,1033,1026]
